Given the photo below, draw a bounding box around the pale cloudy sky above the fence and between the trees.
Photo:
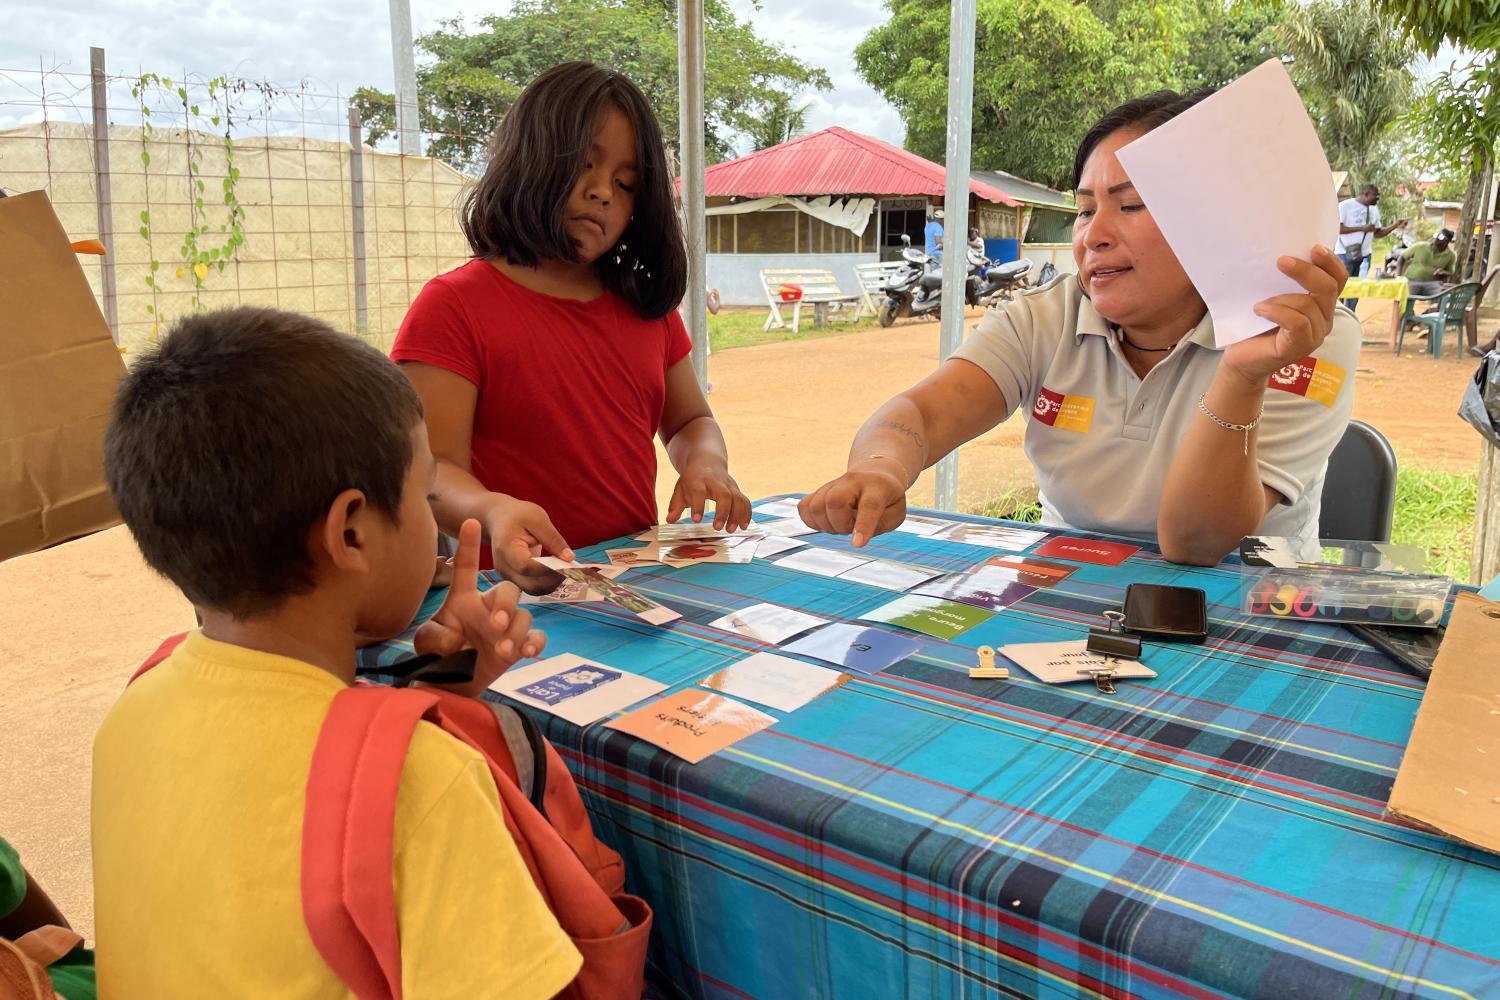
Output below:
[0,0,902,142]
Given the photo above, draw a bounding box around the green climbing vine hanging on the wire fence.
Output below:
[131,73,246,325]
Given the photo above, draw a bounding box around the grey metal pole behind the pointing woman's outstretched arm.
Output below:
[935,0,975,510]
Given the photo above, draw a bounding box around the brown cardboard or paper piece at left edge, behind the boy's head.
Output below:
[0,190,125,559]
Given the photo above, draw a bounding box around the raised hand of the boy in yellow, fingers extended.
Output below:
[413,519,548,697]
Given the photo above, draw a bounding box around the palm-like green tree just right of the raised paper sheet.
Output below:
[1277,0,1416,184]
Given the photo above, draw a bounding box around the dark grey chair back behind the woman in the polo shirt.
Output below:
[1319,420,1397,541]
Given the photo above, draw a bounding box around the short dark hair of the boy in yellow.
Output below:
[104,307,422,618]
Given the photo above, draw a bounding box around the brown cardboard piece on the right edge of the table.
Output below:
[1386,594,1500,853]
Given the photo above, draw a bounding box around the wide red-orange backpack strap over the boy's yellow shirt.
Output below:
[302,688,438,1000]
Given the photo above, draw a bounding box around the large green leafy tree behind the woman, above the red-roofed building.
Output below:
[855,0,1280,187]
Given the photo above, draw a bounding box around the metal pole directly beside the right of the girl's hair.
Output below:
[677,0,708,387]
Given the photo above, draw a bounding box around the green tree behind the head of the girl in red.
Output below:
[353,0,830,171]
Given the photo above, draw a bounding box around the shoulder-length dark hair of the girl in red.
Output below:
[462,63,687,319]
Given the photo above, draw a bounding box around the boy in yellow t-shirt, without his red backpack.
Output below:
[93,309,581,1000]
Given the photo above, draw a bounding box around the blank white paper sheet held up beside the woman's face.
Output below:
[1119,58,1338,348]
